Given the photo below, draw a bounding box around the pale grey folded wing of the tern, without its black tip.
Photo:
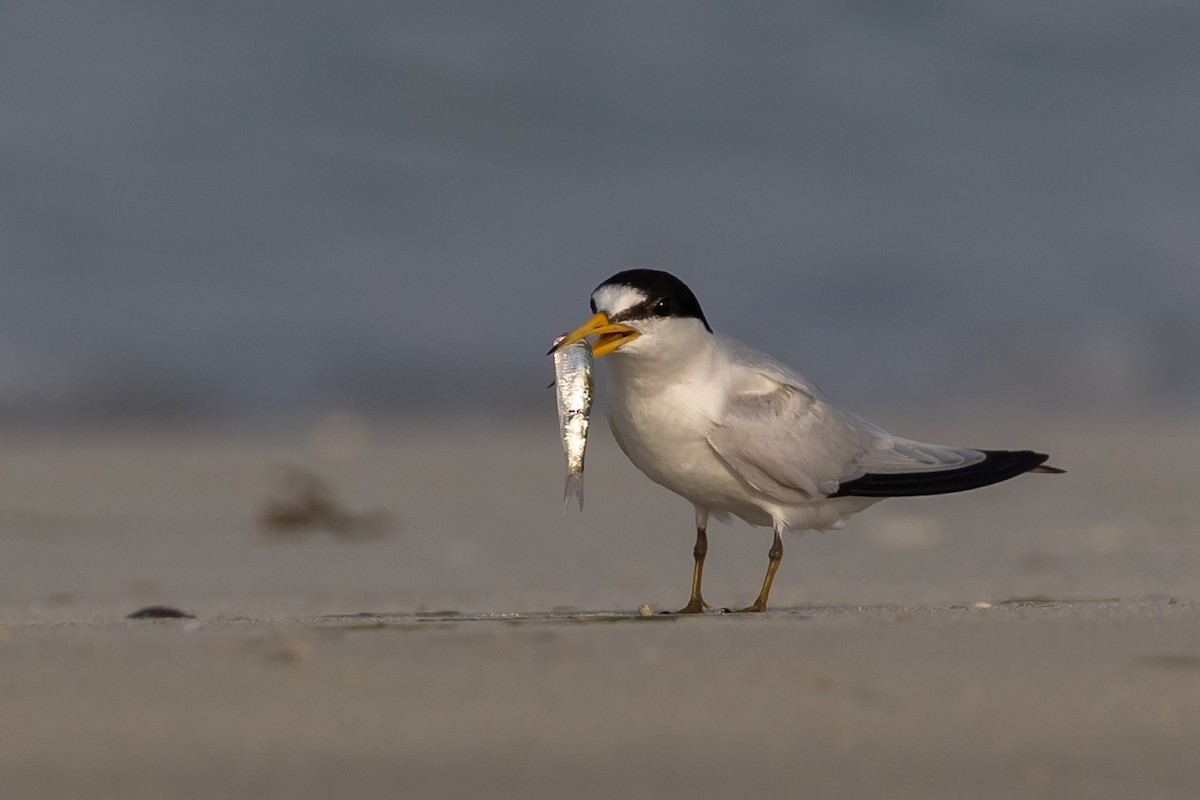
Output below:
[708,337,986,504]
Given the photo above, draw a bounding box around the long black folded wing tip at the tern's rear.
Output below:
[830,450,1066,498]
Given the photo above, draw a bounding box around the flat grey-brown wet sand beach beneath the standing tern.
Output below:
[0,421,1200,799]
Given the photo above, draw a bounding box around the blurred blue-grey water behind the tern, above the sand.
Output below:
[0,0,1200,421]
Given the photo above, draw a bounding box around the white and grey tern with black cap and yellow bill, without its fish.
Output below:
[556,270,1063,613]
